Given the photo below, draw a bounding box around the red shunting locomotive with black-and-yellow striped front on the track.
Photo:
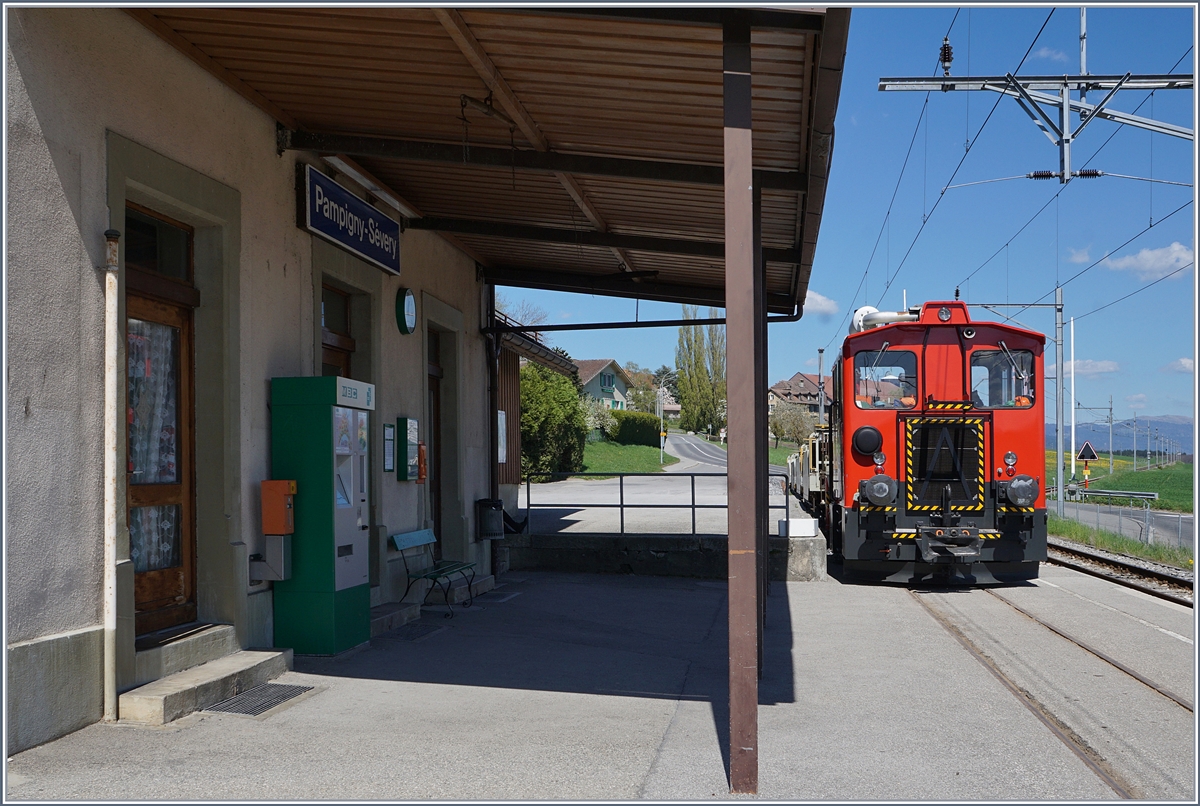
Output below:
[808,301,1046,584]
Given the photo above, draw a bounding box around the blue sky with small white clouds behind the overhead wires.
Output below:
[503,7,1195,421]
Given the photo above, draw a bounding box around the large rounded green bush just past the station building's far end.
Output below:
[521,362,588,475]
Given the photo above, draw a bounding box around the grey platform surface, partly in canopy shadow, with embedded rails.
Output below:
[6,569,1195,802]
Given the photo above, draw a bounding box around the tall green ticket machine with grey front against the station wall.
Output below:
[271,377,374,655]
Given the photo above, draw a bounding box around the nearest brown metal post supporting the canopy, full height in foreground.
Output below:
[722,10,764,794]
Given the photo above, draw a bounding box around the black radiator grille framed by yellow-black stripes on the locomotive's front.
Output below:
[906,417,984,510]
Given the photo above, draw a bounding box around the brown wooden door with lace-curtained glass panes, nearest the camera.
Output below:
[126,295,196,634]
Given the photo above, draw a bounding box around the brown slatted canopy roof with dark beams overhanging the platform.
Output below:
[127,6,850,314]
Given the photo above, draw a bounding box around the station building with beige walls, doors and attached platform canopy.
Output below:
[5,7,848,767]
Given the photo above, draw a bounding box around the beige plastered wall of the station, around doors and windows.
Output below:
[5,8,488,752]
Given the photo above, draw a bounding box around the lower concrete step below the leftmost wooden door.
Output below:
[118,649,292,724]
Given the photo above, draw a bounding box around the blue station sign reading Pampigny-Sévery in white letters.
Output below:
[296,166,400,275]
